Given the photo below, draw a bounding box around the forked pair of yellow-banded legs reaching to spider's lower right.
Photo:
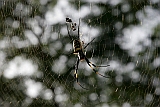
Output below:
[85,56,110,78]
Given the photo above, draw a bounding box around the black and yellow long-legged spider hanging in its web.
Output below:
[66,17,110,90]
